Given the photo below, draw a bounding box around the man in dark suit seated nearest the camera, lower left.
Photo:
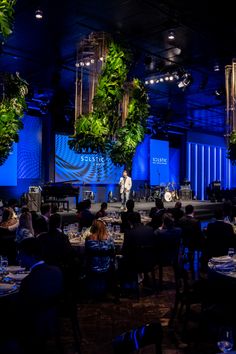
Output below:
[17,237,63,354]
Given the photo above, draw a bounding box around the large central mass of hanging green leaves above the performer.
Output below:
[69,37,148,168]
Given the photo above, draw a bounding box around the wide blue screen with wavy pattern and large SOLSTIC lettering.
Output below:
[55,134,123,185]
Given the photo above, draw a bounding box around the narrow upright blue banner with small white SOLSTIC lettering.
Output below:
[150,139,169,185]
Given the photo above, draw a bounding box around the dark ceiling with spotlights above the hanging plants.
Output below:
[0,0,236,135]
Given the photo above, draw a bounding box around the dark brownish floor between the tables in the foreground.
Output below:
[59,268,218,354]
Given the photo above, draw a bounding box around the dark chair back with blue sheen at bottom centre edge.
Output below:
[112,322,163,354]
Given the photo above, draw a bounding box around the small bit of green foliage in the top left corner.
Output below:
[0,0,16,39]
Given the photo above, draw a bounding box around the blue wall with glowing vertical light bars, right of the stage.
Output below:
[187,133,235,200]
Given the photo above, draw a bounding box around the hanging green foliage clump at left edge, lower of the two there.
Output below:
[0,73,28,165]
